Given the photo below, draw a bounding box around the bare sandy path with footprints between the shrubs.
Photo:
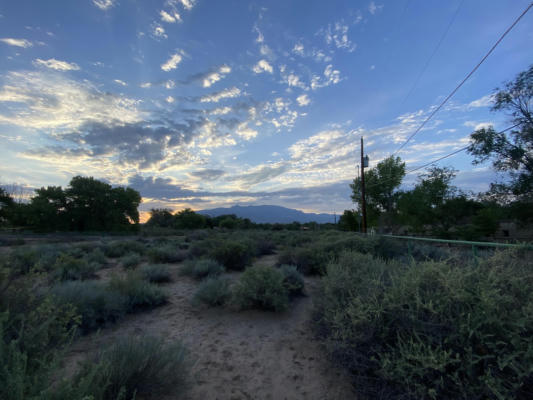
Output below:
[69,256,355,400]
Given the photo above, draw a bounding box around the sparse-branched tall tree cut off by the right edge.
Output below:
[468,65,533,201]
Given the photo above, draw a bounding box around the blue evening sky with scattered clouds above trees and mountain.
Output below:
[0,0,533,219]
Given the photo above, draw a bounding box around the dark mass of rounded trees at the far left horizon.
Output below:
[0,176,142,232]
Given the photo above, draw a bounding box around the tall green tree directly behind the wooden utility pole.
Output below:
[350,156,405,225]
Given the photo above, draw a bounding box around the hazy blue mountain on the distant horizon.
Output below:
[198,205,335,224]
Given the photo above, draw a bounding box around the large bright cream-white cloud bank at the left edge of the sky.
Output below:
[0,71,144,129]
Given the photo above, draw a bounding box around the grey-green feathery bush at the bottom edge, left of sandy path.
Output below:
[52,336,191,400]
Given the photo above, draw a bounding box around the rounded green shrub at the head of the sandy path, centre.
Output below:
[233,266,289,311]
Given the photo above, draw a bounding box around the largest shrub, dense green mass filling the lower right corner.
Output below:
[315,251,533,399]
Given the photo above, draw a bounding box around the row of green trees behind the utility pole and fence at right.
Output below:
[339,65,533,239]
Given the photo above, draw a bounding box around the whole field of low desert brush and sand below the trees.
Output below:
[0,230,533,400]
